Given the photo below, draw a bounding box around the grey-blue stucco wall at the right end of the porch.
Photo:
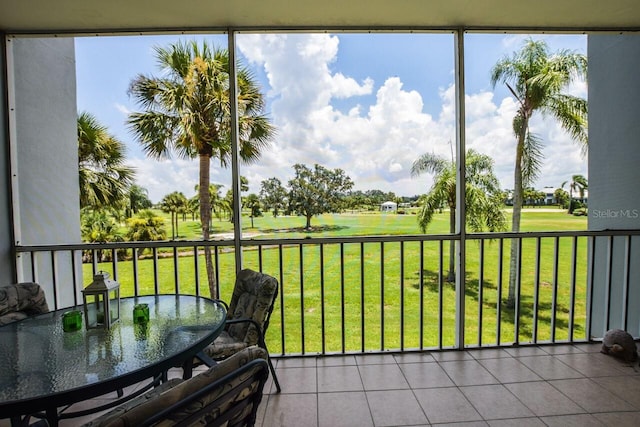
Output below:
[588,34,640,337]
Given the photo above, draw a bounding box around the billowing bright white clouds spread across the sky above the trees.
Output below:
[127,34,586,201]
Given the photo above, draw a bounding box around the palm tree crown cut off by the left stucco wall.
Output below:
[78,112,135,209]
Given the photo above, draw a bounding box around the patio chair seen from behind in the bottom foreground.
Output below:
[83,346,269,427]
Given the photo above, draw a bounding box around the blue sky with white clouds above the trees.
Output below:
[76,33,587,202]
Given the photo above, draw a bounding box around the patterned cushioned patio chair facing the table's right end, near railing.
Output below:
[199,269,280,392]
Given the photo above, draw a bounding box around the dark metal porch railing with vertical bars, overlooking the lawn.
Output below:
[16,230,640,356]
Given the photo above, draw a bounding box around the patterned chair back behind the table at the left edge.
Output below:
[0,282,49,325]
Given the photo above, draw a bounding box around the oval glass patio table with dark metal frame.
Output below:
[0,295,226,425]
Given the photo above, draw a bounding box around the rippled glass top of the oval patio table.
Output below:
[0,295,226,406]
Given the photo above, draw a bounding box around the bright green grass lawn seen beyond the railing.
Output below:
[97,209,587,354]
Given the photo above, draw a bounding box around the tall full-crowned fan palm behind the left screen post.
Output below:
[128,41,275,298]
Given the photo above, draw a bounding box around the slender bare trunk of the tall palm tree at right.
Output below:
[507,120,527,308]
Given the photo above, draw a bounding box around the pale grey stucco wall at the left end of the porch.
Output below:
[11,37,81,307]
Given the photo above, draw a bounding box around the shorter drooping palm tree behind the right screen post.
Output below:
[411,149,506,282]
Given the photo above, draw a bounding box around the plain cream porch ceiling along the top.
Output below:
[0,0,640,33]
